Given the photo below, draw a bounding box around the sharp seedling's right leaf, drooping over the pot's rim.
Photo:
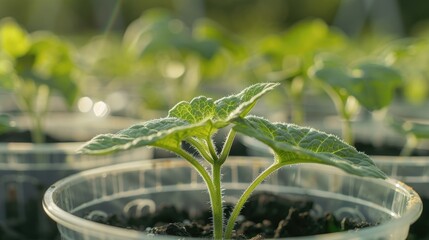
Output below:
[234,116,386,178]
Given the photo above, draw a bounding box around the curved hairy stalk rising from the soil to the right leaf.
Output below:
[224,163,284,239]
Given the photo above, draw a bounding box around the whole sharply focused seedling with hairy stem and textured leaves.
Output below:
[79,83,385,239]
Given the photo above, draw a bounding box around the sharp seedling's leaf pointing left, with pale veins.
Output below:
[79,118,206,154]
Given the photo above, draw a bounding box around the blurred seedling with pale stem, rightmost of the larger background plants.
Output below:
[309,54,402,144]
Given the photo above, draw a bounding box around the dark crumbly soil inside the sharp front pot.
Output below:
[85,193,376,239]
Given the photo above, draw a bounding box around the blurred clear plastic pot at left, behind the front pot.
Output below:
[0,142,152,240]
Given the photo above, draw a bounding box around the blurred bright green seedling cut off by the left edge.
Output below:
[0,18,78,143]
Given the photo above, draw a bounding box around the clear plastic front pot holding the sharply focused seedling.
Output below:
[43,157,422,240]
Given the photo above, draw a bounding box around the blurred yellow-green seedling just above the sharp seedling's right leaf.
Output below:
[249,19,347,124]
